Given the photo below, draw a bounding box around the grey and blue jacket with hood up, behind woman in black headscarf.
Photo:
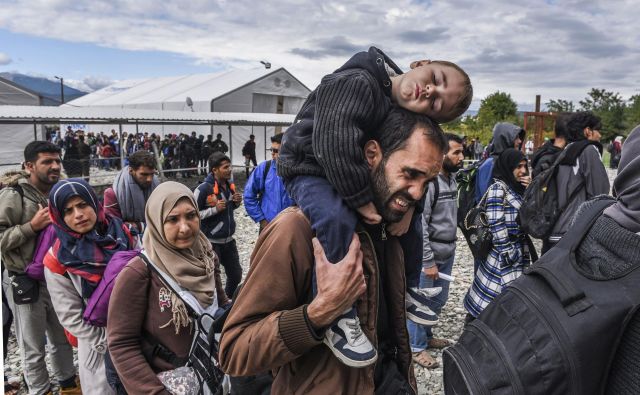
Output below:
[475,122,526,202]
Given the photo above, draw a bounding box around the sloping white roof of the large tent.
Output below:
[67,67,308,106]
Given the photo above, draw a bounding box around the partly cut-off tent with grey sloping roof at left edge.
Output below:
[0,78,44,164]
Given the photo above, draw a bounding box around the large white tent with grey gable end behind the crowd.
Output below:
[66,68,310,165]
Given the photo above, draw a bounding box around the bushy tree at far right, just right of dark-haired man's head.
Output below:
[580,88,626,140]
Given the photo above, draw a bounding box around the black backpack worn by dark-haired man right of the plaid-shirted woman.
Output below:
[519,140,591,239]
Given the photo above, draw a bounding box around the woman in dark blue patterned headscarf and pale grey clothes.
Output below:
[44,178,137,394]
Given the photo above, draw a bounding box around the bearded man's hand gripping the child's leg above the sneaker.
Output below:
[307,234,367,329]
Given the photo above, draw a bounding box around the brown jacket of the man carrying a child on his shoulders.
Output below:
[220,208,416,395]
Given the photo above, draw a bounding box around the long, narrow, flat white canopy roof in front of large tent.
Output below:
[0,106,295,126]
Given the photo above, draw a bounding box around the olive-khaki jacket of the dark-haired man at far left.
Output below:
[0,173,47,273]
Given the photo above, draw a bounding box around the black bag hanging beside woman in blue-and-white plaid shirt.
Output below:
[462,182,507,259]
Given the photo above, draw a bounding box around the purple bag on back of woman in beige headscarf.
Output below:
[82,250,140,326]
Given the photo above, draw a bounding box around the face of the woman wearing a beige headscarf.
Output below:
[163,198,200,250]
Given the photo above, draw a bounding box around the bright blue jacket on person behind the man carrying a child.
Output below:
[244,161,293,222]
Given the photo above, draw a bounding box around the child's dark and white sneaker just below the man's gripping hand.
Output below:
[324,308,378,368]
